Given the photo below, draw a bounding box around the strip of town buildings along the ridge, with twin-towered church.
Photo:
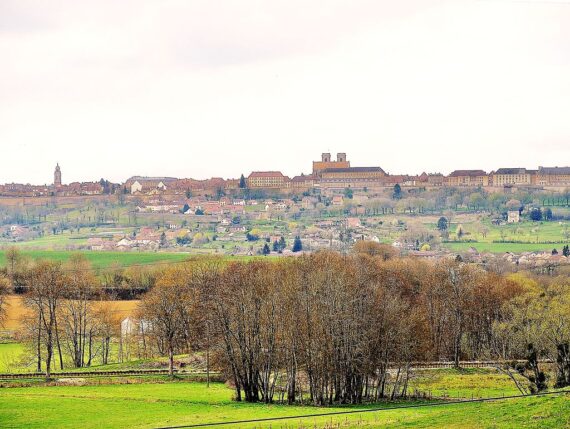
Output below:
[0,153,570,197]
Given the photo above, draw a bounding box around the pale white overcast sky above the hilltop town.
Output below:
[0,0,570,183]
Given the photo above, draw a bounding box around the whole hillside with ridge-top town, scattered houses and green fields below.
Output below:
[0,153,570,266]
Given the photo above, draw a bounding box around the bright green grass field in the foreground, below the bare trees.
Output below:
[0,382,570,429]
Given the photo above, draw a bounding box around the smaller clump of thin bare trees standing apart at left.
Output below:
[0,255,118,378]
